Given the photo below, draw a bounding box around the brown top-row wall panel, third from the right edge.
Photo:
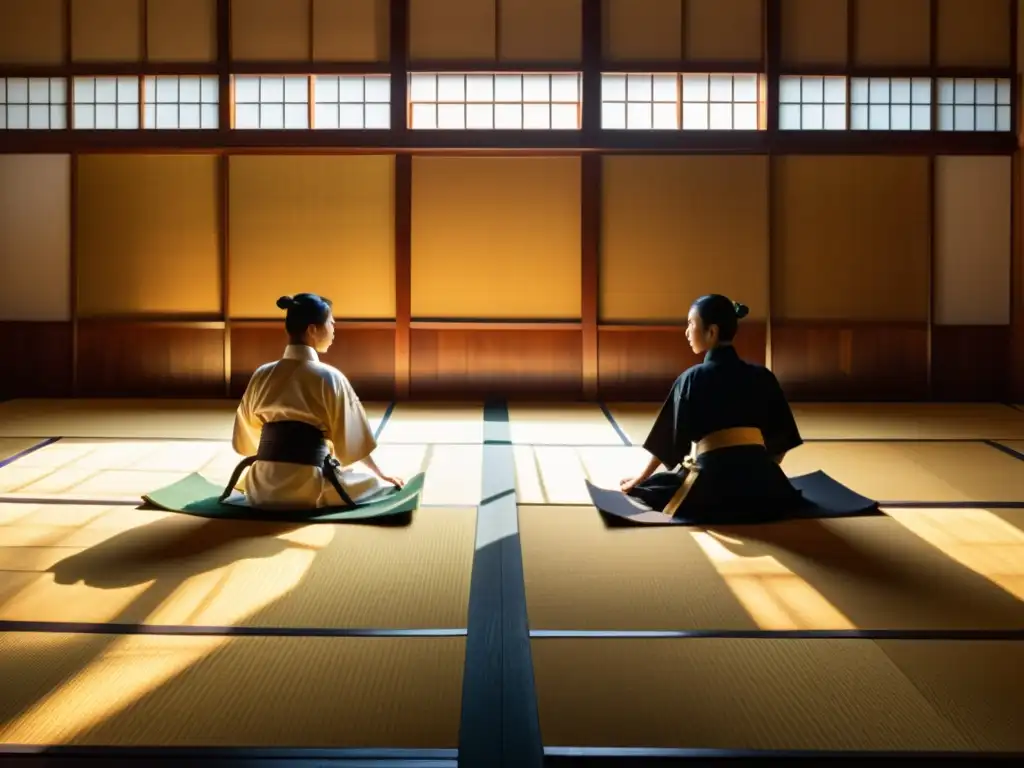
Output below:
[779,0,848,65]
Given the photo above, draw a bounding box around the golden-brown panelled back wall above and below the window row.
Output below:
[0,0,1024,399]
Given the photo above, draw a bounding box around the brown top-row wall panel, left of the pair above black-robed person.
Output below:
[601,0,683,61]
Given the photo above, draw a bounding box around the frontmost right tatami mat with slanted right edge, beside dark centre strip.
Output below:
[532,639,978,751]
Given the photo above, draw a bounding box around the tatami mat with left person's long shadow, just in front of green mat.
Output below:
[0,504,476,629]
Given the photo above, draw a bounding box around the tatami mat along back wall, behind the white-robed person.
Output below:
[0,399,387,440]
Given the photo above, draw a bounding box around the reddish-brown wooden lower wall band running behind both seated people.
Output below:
[8,318,1015,400]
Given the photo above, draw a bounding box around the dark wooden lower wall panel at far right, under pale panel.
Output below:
[931,326,1011,401]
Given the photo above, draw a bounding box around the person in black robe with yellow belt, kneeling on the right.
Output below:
[621,294,823,521]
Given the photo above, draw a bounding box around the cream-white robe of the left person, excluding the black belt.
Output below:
[231,344,390,508]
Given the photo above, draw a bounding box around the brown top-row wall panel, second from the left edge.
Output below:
[71,0,144,61]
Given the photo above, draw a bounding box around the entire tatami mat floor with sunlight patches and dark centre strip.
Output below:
[0,400,1024,766]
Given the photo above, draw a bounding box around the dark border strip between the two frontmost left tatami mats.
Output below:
[0,621,467,638]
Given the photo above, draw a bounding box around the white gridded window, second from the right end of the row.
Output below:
[850,78,932,131]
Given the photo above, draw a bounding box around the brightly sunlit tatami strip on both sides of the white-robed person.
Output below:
[0,438,483,506]
